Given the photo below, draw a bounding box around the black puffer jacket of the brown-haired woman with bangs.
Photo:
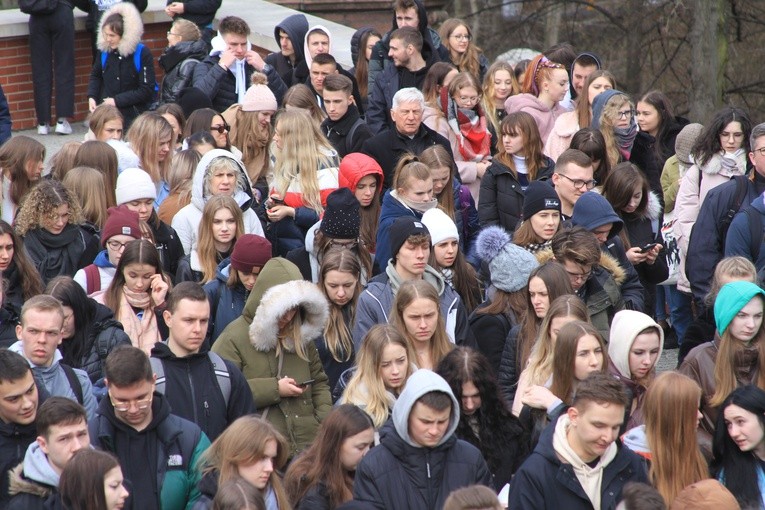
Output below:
[478,156,555,232]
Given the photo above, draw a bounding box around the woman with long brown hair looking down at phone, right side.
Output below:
[602,161,669,317]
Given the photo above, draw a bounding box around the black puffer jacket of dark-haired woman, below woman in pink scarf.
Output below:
[64,299,131,383]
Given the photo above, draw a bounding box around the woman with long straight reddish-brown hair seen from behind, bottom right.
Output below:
[624,372,709,507]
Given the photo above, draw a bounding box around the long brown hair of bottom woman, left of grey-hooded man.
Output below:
[284,404,374,508]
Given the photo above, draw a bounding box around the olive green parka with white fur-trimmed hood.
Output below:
[212,258,332,457]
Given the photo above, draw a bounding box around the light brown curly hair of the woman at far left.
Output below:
[16,179,83,236]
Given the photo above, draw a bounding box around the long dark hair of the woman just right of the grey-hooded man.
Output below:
[436,347,529,481]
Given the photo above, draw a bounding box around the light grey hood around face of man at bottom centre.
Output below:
[393,368,460,448]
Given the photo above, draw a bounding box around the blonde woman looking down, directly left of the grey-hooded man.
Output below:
[340,324,417,429]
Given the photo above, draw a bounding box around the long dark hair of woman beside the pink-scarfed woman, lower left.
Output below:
[45,276,97,368]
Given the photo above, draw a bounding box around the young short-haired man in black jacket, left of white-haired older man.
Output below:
[321,74,372,159]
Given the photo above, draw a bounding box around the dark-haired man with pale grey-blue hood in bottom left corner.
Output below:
[6,397,90,510]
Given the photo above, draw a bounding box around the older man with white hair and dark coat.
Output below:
[361,87,453,189]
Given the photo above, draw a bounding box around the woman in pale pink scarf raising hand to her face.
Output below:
[93,239,170,356]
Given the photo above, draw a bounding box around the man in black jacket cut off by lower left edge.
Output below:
[0,349,39,508]
